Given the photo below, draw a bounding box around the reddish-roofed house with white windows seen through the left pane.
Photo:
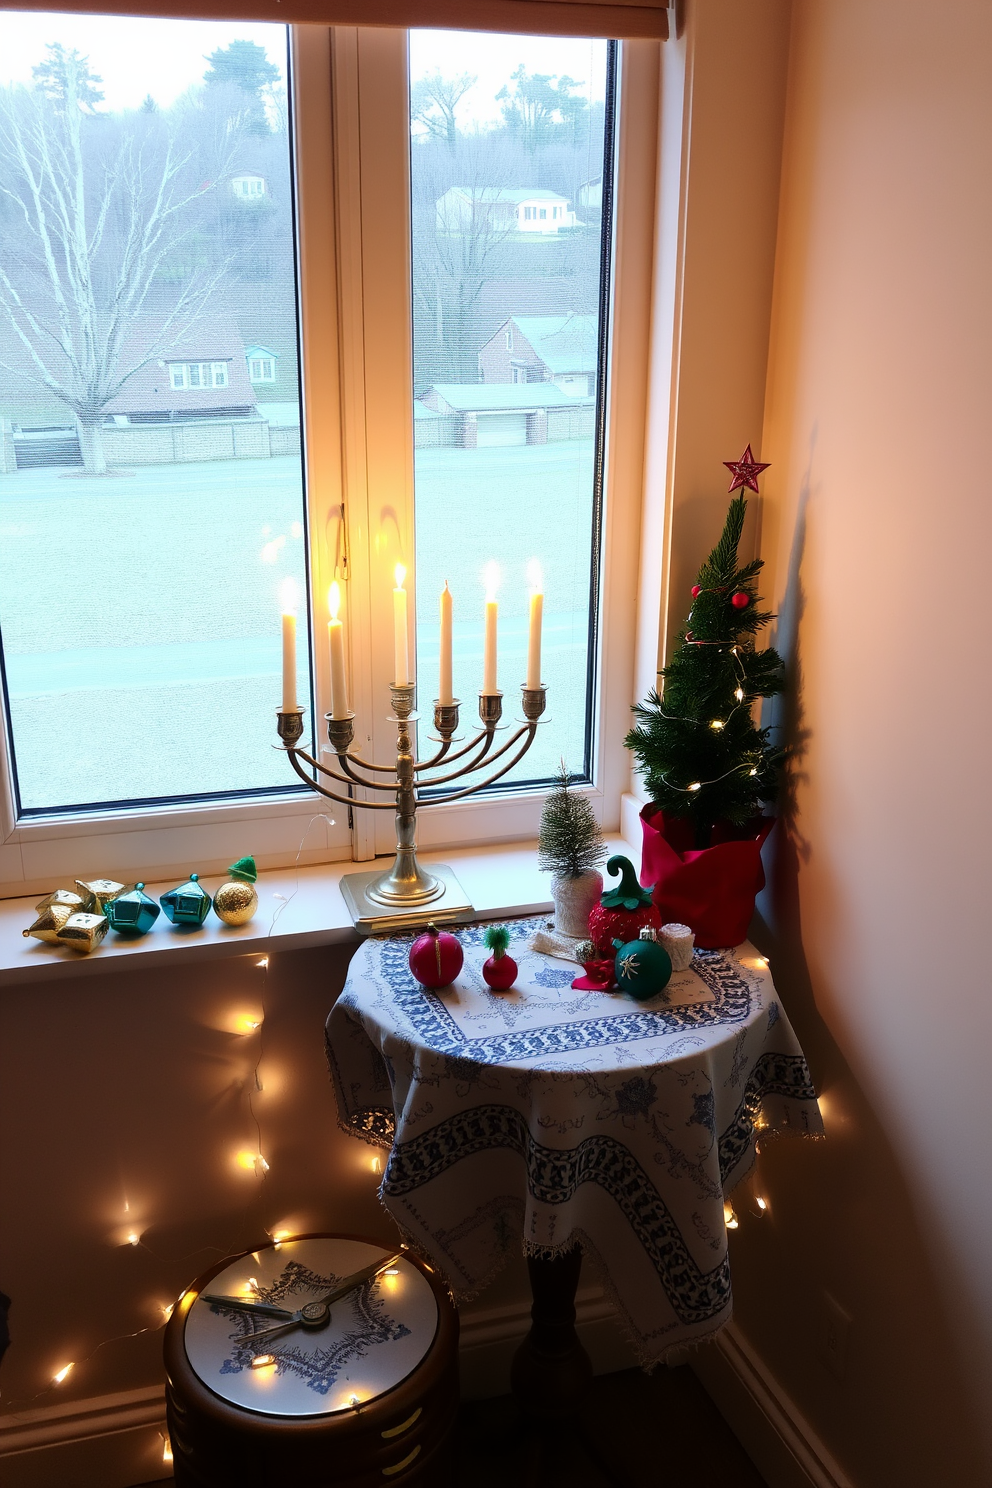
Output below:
[104,318,256,424]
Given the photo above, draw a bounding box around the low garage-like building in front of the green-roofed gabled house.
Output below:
[421,382,595,449]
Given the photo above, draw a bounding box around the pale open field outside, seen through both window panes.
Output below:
[0,440,592,808]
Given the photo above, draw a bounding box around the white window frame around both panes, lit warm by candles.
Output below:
[0,25,660,896]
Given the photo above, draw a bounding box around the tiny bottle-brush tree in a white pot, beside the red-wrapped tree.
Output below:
[537,760,607,940]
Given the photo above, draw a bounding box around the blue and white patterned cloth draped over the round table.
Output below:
[327,920,822,1360]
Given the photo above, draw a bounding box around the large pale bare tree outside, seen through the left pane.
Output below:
[0,46,233,475]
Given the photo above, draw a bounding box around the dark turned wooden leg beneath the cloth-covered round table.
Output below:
[510,1245,592,1421]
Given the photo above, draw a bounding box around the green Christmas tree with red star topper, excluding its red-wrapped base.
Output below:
[625,473,784,848]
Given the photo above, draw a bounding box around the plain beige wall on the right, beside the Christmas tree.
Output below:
[733,0,992,1488]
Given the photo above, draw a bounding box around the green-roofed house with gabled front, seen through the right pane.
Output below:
[479,315,599,397]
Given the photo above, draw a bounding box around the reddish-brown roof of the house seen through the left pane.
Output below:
[104,315,256,414]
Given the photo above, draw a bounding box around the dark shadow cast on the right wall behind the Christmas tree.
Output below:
[732,452,992,1488]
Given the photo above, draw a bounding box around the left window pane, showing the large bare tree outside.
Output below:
[0,12,309,814]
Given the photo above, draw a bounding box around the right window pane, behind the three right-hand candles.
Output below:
[410,31,614,784]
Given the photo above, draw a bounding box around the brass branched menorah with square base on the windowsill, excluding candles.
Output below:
[277,673,547,934]
